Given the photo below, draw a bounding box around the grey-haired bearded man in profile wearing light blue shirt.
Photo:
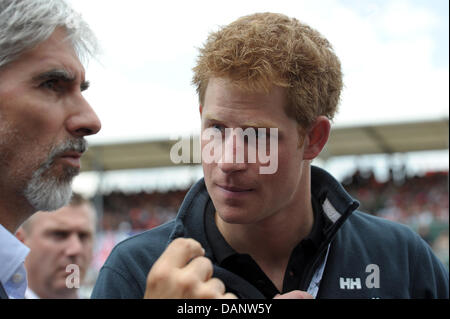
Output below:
[0,0,101,298]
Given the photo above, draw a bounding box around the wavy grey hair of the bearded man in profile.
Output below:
[0,0,98,69]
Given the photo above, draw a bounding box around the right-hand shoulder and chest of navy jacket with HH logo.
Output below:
[321,211,448,298]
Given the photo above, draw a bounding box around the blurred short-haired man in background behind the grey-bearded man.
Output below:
[16,194,96,299]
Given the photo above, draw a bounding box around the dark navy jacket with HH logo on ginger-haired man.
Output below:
[91,167,449,299]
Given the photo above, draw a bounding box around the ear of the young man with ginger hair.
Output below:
[303,116,331,160]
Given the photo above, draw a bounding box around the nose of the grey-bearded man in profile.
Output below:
[66,96,102,137]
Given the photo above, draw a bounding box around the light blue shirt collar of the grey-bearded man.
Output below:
[0,224,30,284]
